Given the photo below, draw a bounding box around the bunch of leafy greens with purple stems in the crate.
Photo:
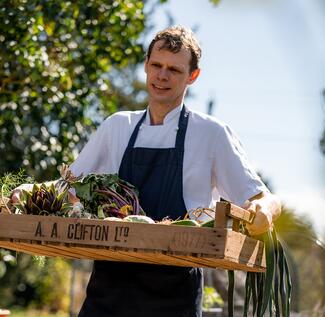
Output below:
[71,174,144,219]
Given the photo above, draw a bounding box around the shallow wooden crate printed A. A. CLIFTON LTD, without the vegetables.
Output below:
[0,203,265,272]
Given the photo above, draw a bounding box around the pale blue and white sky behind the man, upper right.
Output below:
[145,0,325,234]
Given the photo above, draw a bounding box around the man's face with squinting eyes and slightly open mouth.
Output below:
[145,41,199,107]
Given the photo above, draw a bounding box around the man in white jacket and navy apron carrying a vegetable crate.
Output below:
[71,26,280,317]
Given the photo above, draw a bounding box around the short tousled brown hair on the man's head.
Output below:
[147,25,201,72]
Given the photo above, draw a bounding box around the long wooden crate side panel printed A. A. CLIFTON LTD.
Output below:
[0,215,225,255]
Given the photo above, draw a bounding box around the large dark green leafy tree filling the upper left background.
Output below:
[0,0,145,179]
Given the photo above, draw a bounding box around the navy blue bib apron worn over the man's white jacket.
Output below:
[79,106,202,317]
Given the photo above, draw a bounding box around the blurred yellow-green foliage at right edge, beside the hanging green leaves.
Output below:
[275,207,325,316]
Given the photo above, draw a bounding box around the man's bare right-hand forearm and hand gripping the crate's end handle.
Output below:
[243,192,281,236]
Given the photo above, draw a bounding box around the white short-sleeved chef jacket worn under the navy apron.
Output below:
[71,106,268,216]
